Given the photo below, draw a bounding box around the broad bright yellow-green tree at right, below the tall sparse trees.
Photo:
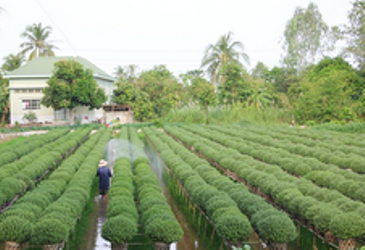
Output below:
[291,58,361,122]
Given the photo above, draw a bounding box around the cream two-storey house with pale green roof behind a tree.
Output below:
[5,57,115,124]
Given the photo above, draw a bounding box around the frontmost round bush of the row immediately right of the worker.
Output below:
[101,215,137,245]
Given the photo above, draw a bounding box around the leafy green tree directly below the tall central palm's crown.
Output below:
[218,63,250,104]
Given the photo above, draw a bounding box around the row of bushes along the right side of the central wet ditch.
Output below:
[143,128,253,246]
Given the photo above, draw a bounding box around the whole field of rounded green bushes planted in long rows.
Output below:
[0,125,365,249]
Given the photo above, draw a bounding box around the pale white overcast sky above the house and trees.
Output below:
[0,0,352,76]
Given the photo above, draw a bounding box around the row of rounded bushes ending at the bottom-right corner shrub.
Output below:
[165,127,365,240]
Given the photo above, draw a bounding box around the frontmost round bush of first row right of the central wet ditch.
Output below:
[216,214,253,242]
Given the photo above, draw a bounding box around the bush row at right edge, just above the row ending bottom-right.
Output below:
[202,127,365,202]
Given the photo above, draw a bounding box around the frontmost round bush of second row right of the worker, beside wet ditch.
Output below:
[145,216,184,244]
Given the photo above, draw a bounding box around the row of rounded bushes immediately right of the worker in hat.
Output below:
[101,127,139,245]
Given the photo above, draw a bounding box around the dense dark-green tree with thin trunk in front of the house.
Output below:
[41,60,107,125]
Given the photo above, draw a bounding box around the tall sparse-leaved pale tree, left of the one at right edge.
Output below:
[283,3,339,71]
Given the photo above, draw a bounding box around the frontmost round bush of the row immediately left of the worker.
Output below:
[31,219,69,245]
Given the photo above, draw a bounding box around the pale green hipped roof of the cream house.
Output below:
[7,56,112,79]
